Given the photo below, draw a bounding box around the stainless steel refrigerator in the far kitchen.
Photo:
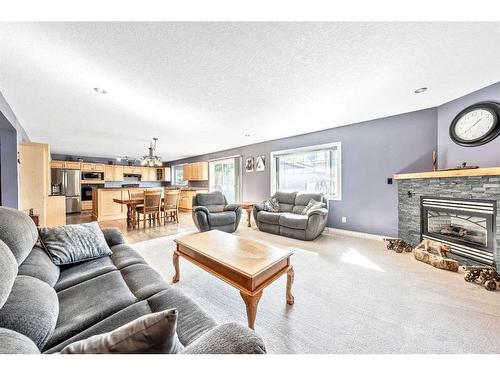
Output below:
[51,168,82,214]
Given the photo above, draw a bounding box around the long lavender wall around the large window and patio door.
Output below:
[169,108,437,236]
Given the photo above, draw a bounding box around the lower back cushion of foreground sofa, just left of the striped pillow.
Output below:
[19,246,60,287]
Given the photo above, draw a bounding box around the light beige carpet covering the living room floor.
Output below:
[133,226,500,353]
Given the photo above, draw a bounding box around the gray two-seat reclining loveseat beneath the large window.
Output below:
[253,191,328,241]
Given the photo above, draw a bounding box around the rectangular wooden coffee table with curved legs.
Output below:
[172,230,294,329]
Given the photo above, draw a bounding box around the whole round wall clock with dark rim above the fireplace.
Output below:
[450,102,500,147]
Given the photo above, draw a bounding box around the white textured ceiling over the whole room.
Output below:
[0,22,500,160]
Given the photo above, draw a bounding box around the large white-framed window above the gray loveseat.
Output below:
[271,142,341,200]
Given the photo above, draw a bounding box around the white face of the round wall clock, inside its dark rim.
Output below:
[455,108,496,142]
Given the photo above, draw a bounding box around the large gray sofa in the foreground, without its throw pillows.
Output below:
[0,207,265,354]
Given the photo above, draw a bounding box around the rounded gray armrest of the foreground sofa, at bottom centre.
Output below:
[180,323,266,354]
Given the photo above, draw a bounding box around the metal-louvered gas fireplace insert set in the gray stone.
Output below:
[420,197,496,266]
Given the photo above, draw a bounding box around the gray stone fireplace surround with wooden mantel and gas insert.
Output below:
[394,168,500,270]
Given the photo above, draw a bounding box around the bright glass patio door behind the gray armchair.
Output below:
[208,156,241,203]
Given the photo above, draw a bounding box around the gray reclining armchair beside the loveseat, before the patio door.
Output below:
[192,191,242,233]
